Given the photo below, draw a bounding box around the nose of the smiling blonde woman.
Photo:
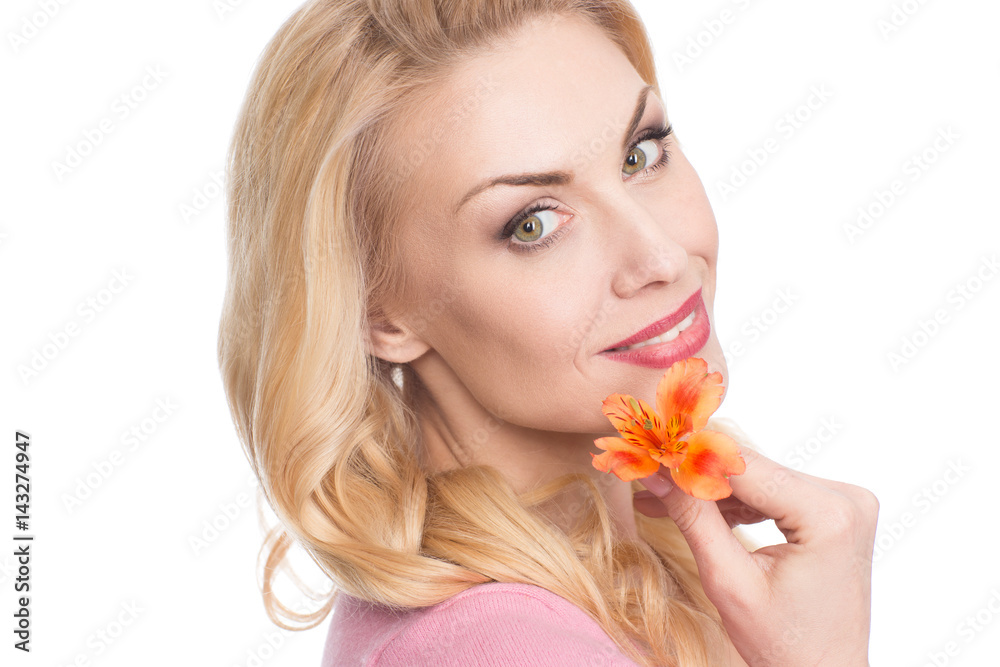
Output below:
[605,190,688,299]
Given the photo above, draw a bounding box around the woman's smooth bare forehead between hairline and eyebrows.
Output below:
[386,11,654,212]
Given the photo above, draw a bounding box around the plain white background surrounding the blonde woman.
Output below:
[0,0,1000,667]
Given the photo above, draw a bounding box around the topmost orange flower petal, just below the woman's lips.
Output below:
[656,357,723,435]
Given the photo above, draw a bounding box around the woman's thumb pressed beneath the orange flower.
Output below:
[639,467,751,585]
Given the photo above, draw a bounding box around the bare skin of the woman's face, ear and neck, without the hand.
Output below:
[376,9,727,538]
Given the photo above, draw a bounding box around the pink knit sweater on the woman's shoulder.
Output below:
[322,583,636,667]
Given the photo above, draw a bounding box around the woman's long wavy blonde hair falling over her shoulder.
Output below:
[218,0,744,666]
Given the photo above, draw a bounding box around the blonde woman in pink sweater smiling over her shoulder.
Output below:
[219,0,877,665]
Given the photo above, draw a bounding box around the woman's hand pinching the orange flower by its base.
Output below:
[634,448,878,667]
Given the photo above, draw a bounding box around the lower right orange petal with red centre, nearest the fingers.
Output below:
[670,431,746,500]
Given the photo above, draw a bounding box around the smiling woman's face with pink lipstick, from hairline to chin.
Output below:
[380,17,726,433]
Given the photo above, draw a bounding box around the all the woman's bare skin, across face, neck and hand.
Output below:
[370,10,877,665]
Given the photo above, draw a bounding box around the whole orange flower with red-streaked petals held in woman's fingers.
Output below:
[590,357,746,500]
